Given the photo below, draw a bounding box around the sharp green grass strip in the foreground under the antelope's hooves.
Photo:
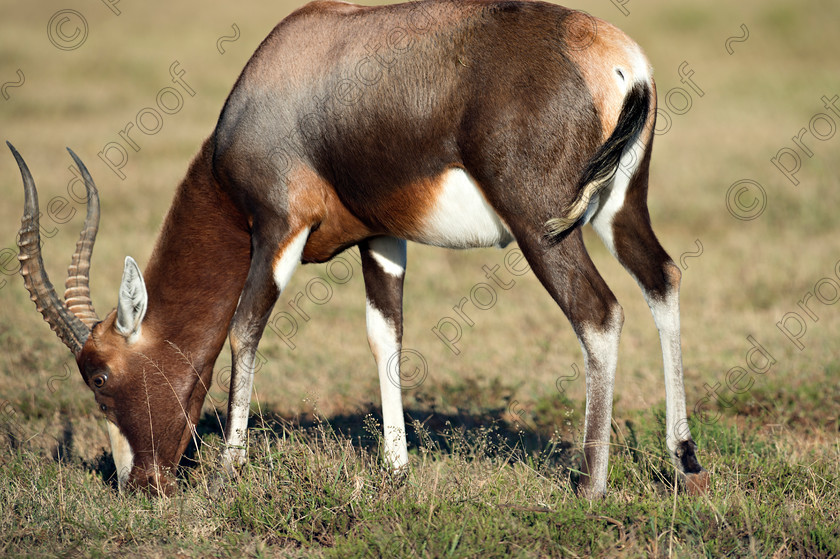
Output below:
[0,396,840,557]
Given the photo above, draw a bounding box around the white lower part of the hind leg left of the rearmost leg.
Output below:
[579,307,623,496]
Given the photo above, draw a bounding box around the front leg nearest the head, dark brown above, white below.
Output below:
[222,228,309,473]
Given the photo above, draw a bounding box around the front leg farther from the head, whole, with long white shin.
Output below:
[359,237,408,471]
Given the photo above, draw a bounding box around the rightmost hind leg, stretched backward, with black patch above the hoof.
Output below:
[592,141,709,493]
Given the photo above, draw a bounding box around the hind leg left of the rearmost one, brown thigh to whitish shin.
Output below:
[517,228,624,499]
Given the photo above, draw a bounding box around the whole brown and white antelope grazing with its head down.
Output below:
[10,0,708,497]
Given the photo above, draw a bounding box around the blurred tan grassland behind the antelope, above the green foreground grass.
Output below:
[0,0,840,468]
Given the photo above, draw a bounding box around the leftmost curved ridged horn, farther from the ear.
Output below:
[6,142,90,355]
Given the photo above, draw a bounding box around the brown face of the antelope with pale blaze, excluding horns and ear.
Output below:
[77,311,209,494]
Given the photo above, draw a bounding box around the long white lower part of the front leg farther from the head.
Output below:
[365,301,408,470]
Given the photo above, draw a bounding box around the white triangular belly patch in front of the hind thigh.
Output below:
[410,168,514,248]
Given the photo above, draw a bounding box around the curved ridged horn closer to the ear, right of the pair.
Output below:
[64,148,99,328]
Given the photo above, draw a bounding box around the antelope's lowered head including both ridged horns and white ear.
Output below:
[8,144,212,494]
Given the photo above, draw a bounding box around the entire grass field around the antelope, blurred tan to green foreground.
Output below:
[0,0,840,557]
